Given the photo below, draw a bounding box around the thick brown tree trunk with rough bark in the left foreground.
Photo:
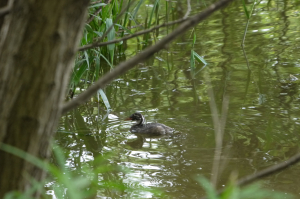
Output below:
[0,0,89,198]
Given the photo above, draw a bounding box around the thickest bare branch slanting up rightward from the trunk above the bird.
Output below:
[62,0,233,113]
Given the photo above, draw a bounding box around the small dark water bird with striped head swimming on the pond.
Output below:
[125,112,174,135]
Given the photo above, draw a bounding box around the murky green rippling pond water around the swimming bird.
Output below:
[55,1,300,198]
